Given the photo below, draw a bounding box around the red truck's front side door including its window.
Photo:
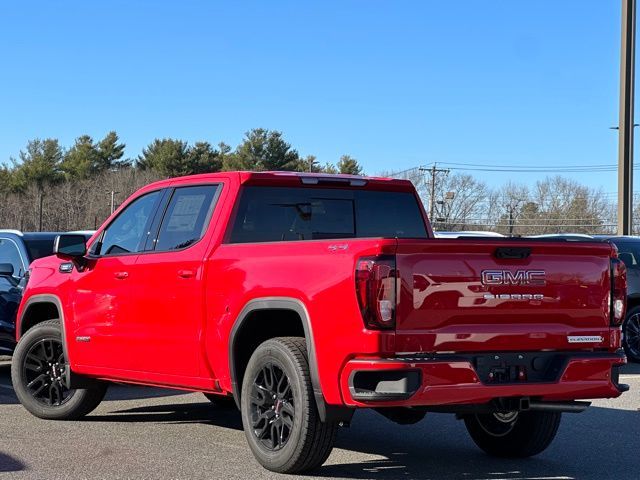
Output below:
[67,190,164,370]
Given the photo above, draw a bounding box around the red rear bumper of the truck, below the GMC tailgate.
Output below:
[340,352,628,407]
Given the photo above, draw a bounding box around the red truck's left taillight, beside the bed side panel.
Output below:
[356,255,397,330]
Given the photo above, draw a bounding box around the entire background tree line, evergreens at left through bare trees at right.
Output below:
[0,128,640,235]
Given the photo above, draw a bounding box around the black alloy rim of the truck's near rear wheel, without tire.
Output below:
[250,363,295,451]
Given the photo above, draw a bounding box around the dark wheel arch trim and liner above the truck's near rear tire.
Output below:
[229,297,327,419]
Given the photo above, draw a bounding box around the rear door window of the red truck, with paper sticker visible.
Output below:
[155,185,219,251]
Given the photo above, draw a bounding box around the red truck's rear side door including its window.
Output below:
[133,184,221,377]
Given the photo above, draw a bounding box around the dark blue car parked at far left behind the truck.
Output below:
[0,230,92,355]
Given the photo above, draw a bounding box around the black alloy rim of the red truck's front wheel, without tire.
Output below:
[23,337,74,406]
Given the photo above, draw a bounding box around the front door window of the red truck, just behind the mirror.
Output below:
[99,191,160,255]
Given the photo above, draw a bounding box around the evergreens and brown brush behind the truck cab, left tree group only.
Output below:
[0,128,364,231]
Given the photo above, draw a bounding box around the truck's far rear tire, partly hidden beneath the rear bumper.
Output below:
[464,412,562,458]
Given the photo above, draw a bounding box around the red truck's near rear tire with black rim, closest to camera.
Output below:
[241,337,338,473]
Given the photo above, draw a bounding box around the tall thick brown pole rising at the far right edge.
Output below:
[618,0,636,235]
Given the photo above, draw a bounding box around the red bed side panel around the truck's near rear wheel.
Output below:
[206,239,395,404]
